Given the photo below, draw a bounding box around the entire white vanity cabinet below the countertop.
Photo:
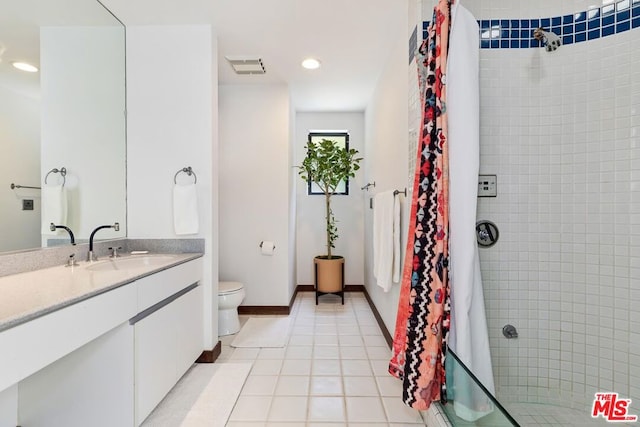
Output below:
[0,258,204,427]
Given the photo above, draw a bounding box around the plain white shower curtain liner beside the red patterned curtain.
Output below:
[446,2,495,421]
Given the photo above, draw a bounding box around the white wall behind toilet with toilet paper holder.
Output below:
[219,84,291,306]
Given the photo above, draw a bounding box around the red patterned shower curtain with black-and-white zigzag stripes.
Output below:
[389,0,450,410]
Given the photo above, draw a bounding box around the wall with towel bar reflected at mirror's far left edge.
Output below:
[0,86,41,252]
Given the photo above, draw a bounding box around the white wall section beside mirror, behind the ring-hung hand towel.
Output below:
[127,25,218,349]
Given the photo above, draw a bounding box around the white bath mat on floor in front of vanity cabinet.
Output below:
[142,362,252,427]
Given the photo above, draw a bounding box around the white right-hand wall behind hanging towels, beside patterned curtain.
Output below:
[363,7,408,334]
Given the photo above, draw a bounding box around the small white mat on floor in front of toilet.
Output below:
[231,317,289,347]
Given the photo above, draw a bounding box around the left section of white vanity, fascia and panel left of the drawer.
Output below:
[5,284,136,427]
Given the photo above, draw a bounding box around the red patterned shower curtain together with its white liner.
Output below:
[389,0,494,414]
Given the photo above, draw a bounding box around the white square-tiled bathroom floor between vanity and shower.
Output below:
[221,293,425,427]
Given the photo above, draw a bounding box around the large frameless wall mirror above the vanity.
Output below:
[0,0,126,252]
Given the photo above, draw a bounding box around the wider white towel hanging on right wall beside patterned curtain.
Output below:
[373,191,395,292]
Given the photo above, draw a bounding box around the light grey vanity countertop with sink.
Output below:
[0,253,203,332]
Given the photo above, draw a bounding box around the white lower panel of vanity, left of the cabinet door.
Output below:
[14,322,133,427]
